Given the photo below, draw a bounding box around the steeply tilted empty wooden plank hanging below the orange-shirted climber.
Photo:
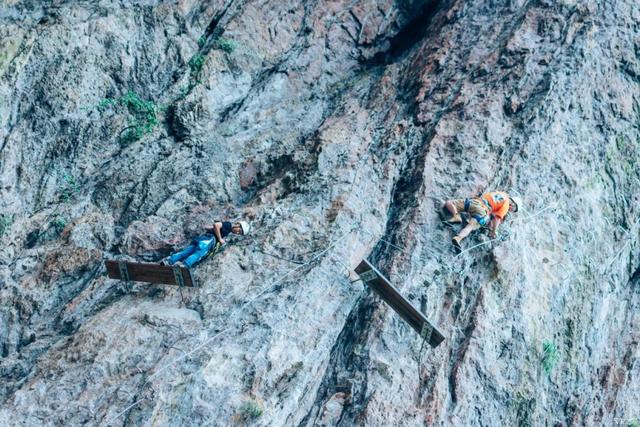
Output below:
[355,259,444,347]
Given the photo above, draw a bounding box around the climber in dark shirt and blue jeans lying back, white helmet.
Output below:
[160,221,251,268]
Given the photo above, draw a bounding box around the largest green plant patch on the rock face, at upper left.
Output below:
[98,91,159,145]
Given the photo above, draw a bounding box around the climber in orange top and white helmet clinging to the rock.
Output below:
[442,191,522,253]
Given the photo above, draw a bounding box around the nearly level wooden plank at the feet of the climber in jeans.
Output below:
[104,261,195,287]
